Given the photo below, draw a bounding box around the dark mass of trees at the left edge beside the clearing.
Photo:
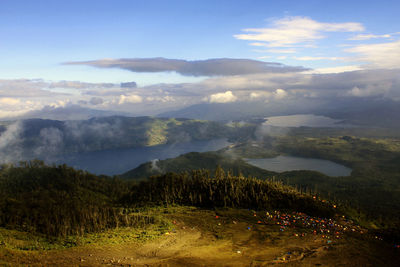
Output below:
[0,161,153,236]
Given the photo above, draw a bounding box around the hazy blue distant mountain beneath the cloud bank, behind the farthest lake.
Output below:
[159,97,400,128]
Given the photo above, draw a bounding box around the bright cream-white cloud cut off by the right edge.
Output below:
[345,40,400,69]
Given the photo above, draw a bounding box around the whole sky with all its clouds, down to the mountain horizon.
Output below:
[0,0,400,118]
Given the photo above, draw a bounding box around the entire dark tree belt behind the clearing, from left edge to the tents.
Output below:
[0,161,334,236]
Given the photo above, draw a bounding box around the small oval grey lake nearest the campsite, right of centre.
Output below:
[246,156,351,176]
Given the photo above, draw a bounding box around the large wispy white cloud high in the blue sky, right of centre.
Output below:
[234,17,364,47]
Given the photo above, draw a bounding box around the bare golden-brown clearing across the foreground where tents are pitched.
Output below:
[2,210,400,266]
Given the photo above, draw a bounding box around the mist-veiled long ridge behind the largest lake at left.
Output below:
[0,116,247,171]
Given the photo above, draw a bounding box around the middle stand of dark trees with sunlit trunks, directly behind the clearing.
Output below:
[122,167,335,217]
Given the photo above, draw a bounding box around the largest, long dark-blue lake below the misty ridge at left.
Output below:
[50,139,230,175]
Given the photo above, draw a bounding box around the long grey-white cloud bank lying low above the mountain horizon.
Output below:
[0,61,400,120]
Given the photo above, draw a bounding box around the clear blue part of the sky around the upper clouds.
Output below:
[0,0,400,84]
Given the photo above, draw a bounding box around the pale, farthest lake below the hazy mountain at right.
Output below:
[263,114,350,127]
